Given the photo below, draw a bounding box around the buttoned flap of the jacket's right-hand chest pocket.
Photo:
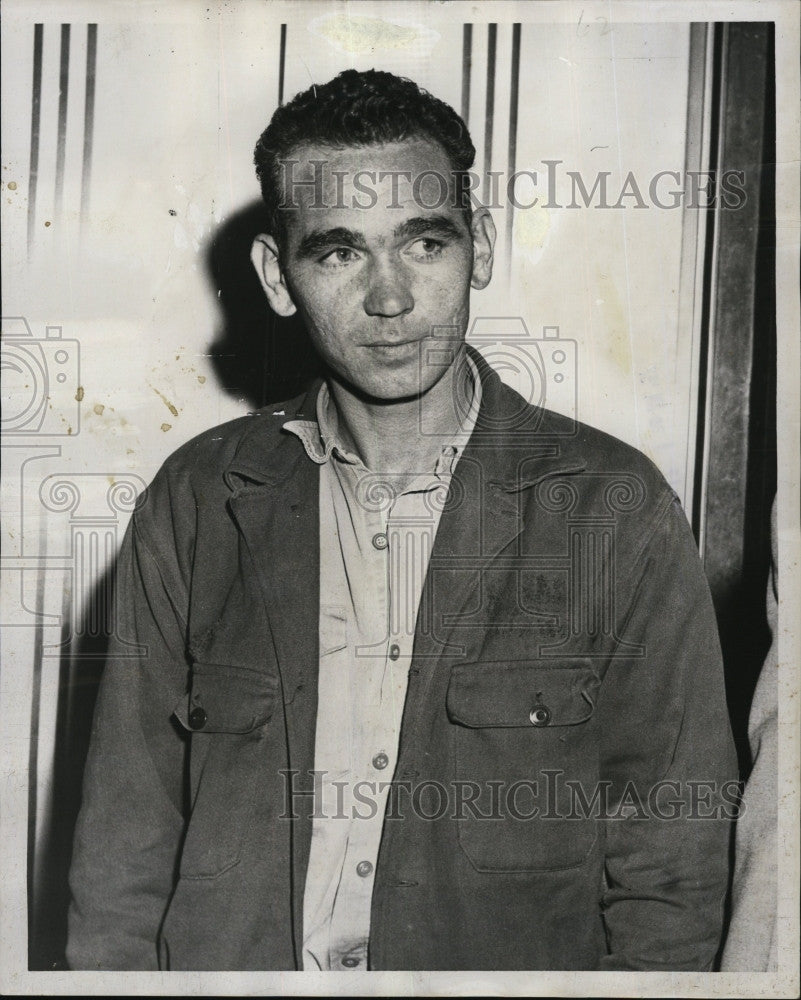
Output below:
[446,660,600,729]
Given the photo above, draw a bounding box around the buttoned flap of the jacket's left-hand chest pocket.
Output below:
[174,663,278,733]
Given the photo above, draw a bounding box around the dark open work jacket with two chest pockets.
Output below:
[68,364,736,970]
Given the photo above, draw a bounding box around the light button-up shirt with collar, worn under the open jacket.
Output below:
[284,353,481,971]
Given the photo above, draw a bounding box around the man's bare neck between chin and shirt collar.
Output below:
[329,347,471,474]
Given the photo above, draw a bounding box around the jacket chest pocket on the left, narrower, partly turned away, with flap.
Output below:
[174,663,278,878]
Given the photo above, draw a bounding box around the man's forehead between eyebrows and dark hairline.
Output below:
[279,138,462,239]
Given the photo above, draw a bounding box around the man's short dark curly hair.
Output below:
[254,69,476,243]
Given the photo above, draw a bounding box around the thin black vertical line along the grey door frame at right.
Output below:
[691,24,724,542]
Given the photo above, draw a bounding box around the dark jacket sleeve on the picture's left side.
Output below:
[67,495,187,970]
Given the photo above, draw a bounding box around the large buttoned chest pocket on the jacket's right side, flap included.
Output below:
[446,661,600,872]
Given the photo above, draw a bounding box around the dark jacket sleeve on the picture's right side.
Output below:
[598,497,737,970]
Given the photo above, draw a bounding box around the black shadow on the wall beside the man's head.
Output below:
[206,201,320,409]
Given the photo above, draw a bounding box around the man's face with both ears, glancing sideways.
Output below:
[254,139,495,401]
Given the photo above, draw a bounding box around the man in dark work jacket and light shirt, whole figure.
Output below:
[69,71,735,970]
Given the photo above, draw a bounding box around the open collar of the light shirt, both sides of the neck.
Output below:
[284,351,482,475]
